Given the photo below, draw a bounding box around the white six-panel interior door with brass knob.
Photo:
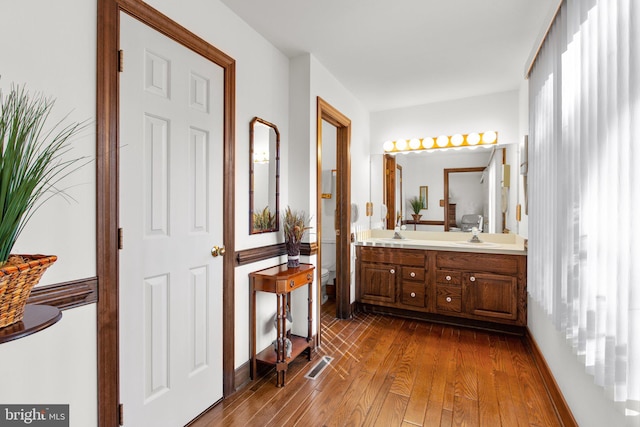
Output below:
[119,13,224,427]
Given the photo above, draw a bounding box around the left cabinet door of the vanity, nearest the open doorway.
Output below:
[359,263,398,304]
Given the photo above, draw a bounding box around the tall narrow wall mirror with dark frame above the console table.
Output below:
[249,117,280,234]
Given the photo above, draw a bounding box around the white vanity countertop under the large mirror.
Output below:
[355,230,527,255]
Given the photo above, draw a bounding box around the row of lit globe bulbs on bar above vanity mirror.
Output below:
[382,131,498,153]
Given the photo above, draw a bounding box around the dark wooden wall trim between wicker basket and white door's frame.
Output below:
[27,277,98,310]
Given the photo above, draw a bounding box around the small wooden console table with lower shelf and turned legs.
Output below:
[249,264,315,387]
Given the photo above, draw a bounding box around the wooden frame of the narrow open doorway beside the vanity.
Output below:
[316,96,352,328]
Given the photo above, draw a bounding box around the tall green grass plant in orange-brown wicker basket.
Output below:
[0,85,84,328]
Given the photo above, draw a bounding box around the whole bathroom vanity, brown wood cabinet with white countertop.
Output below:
[356,230,527,332]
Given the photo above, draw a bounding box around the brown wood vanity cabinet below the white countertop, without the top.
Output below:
[356,246,527,327]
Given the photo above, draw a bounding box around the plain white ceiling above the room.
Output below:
[221,0,559,111]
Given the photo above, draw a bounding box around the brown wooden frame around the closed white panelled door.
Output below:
[96,0,235,427]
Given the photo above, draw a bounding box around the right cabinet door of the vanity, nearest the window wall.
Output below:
[462,273,518,320]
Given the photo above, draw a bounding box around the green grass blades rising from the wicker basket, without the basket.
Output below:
[0,85,85,265]
